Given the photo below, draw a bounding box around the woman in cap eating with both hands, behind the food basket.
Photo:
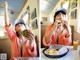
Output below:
[43,8,71,47]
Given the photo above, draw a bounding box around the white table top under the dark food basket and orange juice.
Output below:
[41,45,80,60]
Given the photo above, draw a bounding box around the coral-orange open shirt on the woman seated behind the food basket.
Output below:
[43,26,71,47]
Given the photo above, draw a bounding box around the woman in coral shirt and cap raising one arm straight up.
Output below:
[4,2,37,60]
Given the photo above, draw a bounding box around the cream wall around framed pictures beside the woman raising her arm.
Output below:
[27,0,39,38]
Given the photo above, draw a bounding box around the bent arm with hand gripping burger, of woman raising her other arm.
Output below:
[23,29,37,57]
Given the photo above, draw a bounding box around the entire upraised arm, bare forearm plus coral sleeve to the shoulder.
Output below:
[4,2,16,40]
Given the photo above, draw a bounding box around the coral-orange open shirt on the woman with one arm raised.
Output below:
[5,25,37,60]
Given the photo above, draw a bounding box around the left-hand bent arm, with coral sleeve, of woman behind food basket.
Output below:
[43,21,60,46]
